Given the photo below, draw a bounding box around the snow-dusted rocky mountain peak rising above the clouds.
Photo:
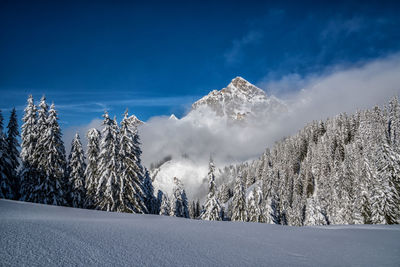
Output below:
[191,77,286,121]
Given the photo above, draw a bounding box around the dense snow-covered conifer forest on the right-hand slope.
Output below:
[206,97,400,226]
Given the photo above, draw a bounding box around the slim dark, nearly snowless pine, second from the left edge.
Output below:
[7,108,21,199]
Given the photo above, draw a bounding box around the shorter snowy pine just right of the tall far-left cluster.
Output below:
[68,133,86,208]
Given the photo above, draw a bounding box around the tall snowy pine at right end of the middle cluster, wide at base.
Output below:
[117,111,153,213]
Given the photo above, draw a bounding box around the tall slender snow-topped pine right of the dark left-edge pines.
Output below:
[19,95,38,201]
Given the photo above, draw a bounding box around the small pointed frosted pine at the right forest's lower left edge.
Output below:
[231,174,247,222]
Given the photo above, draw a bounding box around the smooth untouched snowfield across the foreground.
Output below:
[0,200,400,266]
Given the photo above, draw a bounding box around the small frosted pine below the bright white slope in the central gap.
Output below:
[170,177,189,218]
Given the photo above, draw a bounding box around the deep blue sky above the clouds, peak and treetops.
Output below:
[0,1,400,127]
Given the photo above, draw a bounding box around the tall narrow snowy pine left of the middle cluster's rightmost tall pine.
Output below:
[95,112,121,212]
